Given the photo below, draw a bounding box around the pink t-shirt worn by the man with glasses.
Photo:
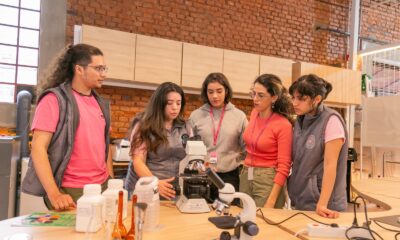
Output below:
[31,92,108,188]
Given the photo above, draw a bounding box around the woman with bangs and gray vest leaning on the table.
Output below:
[288,74,348,218]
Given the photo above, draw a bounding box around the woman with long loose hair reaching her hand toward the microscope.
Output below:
[125,82,192,199]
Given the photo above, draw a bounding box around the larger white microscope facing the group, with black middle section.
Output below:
[174,140,211,213]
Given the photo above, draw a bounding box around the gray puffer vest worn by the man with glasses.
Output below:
[22,83,110,196]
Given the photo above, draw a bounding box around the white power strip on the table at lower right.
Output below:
[307,223,349,238]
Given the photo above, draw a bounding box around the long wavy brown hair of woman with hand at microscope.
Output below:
[131,82,185,152]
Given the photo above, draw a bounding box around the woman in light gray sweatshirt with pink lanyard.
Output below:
[189,73,247,200]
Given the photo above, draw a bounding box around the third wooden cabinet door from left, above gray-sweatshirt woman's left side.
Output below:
[182,43,223,89]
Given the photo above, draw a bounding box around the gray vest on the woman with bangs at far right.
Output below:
[288,104,348,211]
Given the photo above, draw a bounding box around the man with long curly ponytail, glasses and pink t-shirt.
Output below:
[22,44,113,210]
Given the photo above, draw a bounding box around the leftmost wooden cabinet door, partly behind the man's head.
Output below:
[82,25,136,80]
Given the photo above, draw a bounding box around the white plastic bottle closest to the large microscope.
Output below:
[134,176,160,231]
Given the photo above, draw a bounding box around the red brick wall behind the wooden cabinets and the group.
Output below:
[66,0,400,137]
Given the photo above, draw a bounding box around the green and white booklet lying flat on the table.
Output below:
[21,212,76,227]
